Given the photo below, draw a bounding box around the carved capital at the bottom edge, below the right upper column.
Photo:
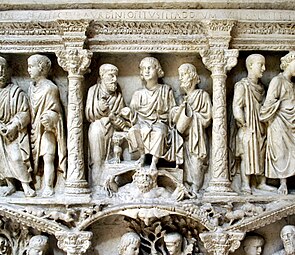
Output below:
[200,231,245,255]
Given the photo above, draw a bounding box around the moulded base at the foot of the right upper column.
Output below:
[203,181,238,197]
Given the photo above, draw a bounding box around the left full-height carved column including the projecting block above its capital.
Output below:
[56,20,92,194]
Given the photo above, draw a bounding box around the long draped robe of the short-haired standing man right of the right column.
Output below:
[233,78,266,175]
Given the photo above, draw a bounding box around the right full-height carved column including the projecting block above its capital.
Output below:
[201,21,239,196]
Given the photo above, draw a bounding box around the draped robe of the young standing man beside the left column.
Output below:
[28,79,67,174]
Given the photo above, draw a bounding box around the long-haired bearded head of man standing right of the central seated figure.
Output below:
[178,64,201,93]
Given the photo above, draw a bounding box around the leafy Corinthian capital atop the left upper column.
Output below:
[56,48,92,75]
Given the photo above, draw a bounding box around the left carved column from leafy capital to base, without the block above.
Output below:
[56,48,92,194]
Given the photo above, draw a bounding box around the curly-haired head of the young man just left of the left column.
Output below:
[28,54,51,80]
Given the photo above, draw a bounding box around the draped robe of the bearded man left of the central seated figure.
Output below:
[85,83,124,168]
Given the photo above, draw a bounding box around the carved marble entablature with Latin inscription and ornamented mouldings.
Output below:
[0,9,295,52]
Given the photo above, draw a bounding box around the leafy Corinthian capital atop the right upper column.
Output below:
[200,48,239,75]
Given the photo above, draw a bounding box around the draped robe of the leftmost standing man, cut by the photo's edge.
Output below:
[0,84,32,183]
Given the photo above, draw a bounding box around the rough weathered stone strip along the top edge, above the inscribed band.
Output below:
[1,0,295,10]
